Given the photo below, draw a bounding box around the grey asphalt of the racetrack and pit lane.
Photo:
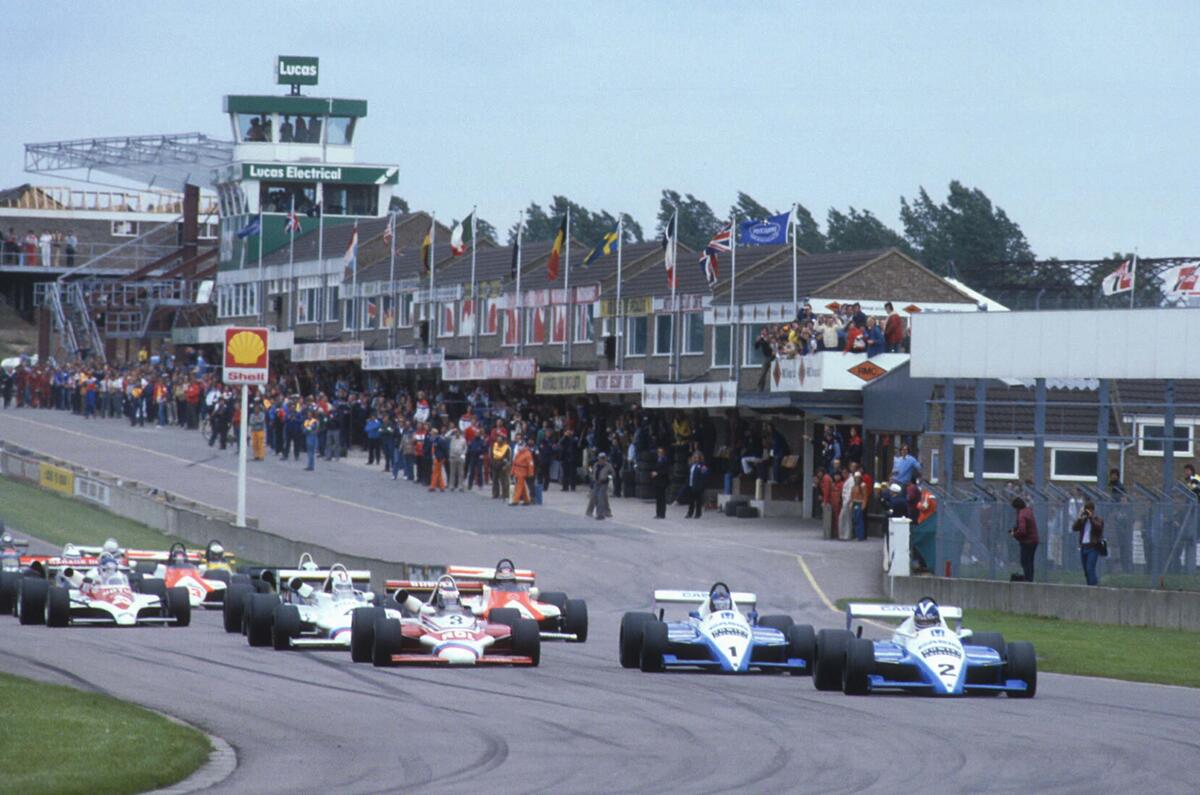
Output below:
[0,410,1200,793]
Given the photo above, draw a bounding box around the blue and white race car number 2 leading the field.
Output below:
[812,598,1038,699]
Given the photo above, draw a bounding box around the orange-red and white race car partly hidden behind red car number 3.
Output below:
[385,557,588,644]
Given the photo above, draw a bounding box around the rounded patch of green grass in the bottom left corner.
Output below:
[0,674,211,795]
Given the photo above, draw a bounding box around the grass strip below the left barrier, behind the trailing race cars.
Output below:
[0,478,182,549]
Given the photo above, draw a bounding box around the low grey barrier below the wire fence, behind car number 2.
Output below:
[883,574,1200,632]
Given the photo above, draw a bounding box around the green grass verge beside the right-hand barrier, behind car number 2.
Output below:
[838,598,1200,687]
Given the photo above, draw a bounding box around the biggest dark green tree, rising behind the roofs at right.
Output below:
[900,180,1036,281]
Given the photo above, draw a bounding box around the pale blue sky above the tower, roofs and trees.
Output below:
[0,0,1200,259]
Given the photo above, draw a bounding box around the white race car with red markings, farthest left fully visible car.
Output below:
[17,555,192,627]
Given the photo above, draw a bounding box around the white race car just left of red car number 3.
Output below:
[223,552,379,651]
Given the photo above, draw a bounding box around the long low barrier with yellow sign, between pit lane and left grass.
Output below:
[0,441,445,587]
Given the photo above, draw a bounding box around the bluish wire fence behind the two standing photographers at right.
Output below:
[918,484,1200,591]
